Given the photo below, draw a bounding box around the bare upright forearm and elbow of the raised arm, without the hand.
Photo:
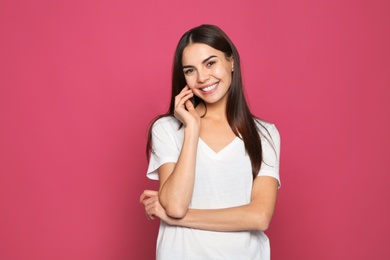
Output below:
[159,128,199,218]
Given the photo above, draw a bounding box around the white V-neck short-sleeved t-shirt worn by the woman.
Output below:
[147,117,280,260]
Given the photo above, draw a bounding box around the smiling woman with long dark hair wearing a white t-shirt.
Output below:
[140,25,280,260]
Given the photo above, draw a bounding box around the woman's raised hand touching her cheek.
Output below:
[174,86,200,130]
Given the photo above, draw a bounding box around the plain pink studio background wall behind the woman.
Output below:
[0,0,390,260]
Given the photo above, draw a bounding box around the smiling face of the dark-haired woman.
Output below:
[182,43,233,104]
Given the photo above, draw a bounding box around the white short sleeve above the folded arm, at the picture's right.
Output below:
[258,123,281,187]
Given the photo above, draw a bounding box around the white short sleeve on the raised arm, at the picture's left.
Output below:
[146,118,180,180]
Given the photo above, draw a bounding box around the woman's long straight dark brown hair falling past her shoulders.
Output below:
[146,25,263,179]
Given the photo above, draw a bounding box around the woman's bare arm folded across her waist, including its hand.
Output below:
[141,176,278,231]
